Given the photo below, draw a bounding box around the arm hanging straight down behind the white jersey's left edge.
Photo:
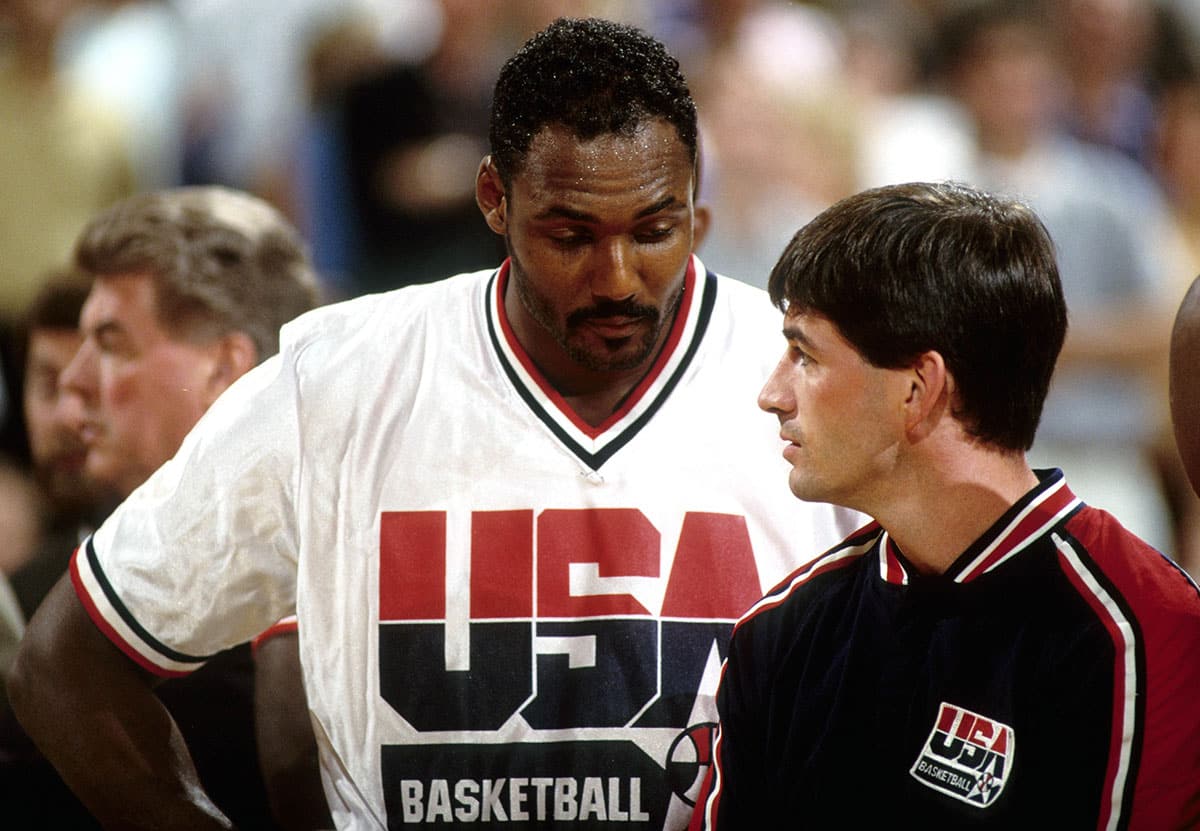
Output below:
[254,632,334,831]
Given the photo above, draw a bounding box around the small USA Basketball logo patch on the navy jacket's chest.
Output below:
[908,701,1015,808]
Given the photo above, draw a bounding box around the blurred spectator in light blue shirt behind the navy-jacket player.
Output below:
[942,0,1177,554]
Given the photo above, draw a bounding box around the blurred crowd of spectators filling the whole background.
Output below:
[0,0,1200,574]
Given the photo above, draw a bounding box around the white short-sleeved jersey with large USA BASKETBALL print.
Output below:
[72,258,858,830]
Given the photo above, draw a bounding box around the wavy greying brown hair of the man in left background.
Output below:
[76,186,319,360]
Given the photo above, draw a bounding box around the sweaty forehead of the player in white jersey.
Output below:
[514,119,692,202]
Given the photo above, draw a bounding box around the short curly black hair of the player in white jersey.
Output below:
[490,18,696,186]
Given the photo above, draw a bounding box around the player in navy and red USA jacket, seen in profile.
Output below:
[694,184,1200,831]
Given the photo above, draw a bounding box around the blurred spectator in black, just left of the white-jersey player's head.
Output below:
[328,0,508,293]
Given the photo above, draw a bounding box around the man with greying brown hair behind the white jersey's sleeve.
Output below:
[14,187,319,827]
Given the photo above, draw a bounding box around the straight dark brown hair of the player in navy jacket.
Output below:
[768,183,1067,450]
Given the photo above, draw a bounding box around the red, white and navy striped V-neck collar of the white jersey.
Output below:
[486,256,716,471]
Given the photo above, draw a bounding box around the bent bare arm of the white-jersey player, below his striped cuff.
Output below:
[8,576,233,831]
